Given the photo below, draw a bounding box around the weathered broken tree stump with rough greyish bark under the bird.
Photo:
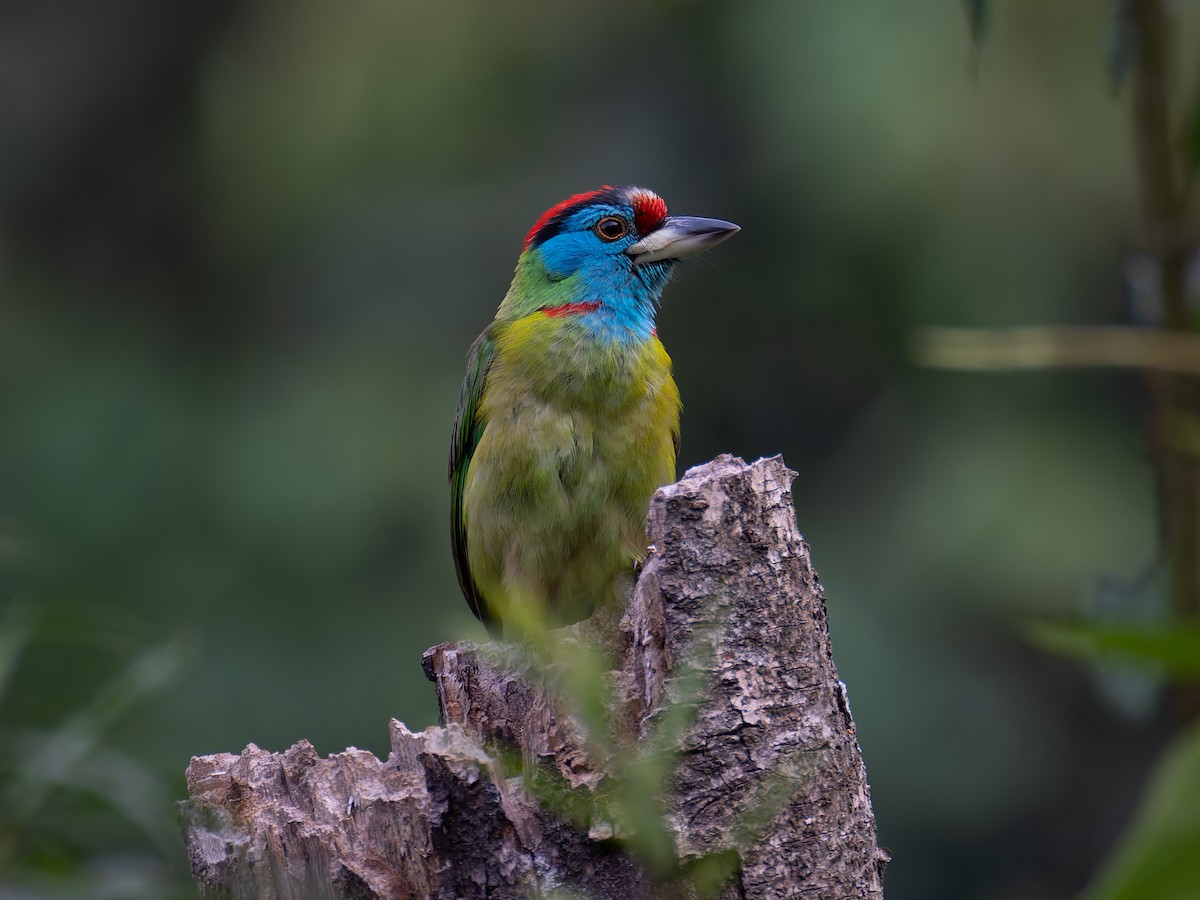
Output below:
[185,456,887,900]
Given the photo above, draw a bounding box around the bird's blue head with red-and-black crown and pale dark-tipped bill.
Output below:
[502,186,739,334]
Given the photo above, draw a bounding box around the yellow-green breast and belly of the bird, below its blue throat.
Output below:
[462,312,680,624]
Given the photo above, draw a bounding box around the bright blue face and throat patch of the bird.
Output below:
[538,203,674,340]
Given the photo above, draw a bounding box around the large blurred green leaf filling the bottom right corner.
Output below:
[1084,727,1200,900]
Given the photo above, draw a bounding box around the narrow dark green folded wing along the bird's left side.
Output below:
[449,328,498,631]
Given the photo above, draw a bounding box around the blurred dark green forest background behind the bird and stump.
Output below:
[0,0,1200,900]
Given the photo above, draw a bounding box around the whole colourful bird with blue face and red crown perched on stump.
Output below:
[448,185,740,636]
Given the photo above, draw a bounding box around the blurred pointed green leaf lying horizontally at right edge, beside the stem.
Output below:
[1028,622,1200,678]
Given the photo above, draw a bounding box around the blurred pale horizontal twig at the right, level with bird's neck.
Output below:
[912,325,1200,374]
